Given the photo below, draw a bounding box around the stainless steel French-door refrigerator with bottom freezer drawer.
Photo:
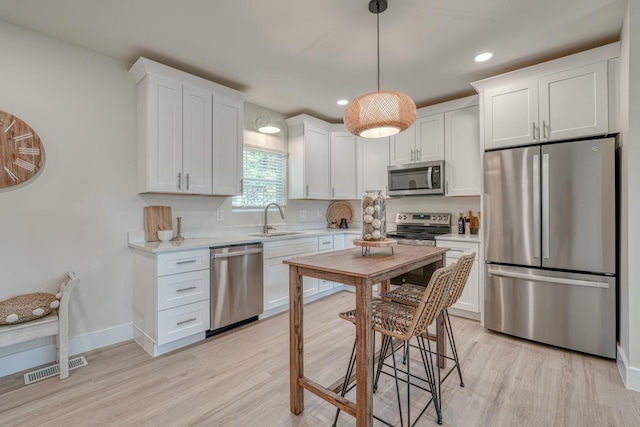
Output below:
[483,137,617,358]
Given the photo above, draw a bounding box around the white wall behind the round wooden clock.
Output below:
[0,21,143,375]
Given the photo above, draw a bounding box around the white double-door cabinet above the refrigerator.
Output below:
[472,42,620,149]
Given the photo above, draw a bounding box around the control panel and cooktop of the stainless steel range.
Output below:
[387,212,451,246]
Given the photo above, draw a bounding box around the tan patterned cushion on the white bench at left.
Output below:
[0,292,60,325]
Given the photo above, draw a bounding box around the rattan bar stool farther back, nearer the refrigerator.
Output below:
[380,252,476,387]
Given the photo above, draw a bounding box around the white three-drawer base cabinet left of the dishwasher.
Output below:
[133,249,211,356]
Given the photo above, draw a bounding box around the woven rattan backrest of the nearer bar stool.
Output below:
[411,264,456,335]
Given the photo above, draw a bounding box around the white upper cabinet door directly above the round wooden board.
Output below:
[330,131,358,200]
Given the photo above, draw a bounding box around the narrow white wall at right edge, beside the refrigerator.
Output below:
[618,2,640,391]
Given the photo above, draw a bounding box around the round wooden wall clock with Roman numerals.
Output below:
[0,111,44,189]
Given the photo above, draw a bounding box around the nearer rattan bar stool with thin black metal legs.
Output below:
[333,266,454,426]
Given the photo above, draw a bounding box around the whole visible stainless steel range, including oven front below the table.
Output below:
[387,212,451,286]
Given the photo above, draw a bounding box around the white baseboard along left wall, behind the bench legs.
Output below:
[0,323,133,377]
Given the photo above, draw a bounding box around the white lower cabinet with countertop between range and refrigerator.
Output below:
[436,238,480,319]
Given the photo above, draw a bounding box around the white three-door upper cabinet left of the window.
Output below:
[129,58,244,195]
